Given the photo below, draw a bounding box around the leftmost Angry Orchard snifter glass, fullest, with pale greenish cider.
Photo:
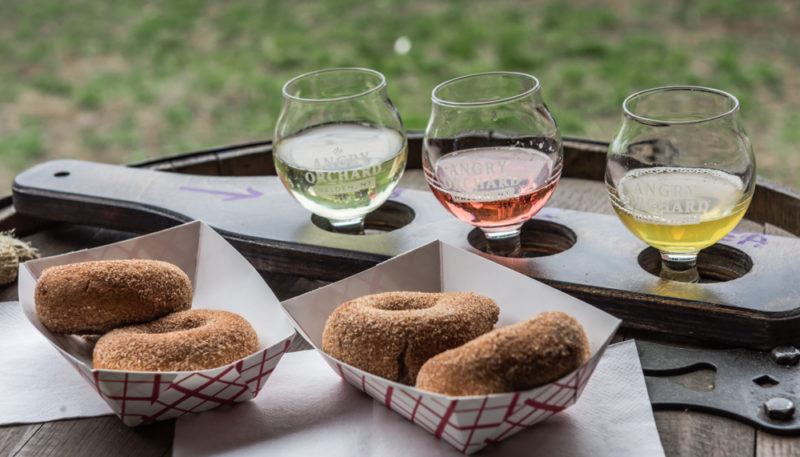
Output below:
[273,68,407,233]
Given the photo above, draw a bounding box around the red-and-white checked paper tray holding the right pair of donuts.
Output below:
[282,241,620,454]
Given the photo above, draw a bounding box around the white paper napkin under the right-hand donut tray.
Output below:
[173,341,664,457]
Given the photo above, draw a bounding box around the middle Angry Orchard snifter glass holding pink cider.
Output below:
[422,72,562,257]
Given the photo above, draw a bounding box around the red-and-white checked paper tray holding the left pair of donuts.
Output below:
[19,222,294,426]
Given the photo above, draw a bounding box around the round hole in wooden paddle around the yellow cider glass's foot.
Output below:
[639,244,753,283]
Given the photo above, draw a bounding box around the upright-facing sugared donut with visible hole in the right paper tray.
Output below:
[322,292,499,385]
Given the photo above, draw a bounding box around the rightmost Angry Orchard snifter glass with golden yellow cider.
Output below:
[605,86,756,282]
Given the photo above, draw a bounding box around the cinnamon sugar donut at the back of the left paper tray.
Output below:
[34,259,192,334]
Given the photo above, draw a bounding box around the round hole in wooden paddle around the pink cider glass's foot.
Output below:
[467,219,578,257]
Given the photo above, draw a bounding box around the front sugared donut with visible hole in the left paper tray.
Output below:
[92,309,258,371]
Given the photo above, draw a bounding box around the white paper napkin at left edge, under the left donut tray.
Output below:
[0,302,111,425]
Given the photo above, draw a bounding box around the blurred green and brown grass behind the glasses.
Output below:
[0,0,800,189]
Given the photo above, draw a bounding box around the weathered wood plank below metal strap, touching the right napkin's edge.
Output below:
[655,411,756,457]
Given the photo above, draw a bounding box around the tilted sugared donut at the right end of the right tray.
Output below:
[416,311,589,396]
